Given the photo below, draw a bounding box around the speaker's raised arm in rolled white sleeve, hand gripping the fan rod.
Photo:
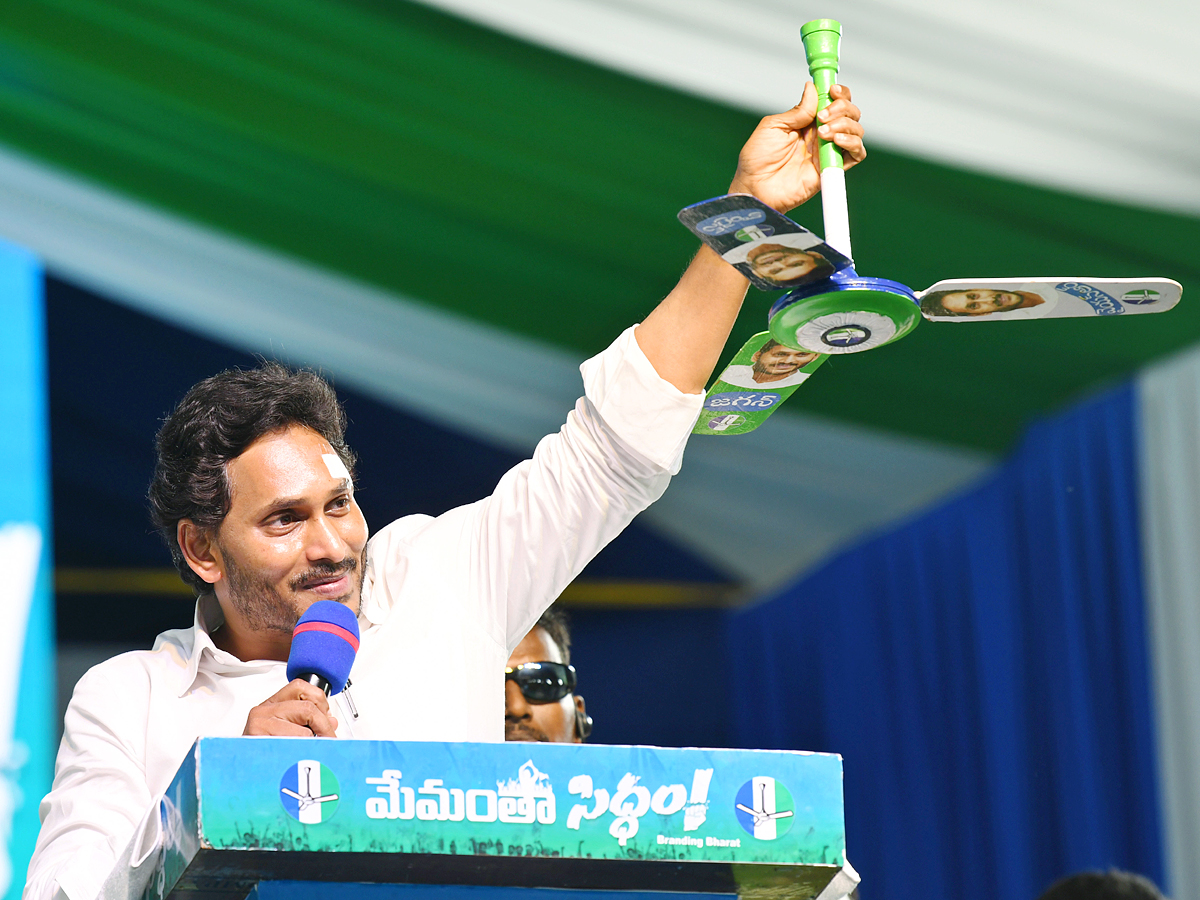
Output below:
[373,84,865,656]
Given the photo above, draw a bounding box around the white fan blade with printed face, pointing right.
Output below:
[917,277,1183,322]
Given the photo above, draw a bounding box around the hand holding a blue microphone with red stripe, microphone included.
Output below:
[242,600,359,738]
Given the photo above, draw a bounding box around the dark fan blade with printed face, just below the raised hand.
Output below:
[679,193,850,290]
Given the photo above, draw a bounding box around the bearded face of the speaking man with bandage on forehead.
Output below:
[215,426,367,635]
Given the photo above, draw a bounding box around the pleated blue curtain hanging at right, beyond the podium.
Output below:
[728,386,1163,900]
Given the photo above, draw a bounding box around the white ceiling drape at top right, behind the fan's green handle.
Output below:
[424,0,1200,214]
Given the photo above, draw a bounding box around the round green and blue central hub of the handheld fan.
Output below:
[769,269,920,354]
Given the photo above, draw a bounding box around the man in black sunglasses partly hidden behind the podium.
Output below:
[504,606,592,744]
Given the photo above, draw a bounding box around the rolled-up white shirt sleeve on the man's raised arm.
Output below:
[462,328,703,653]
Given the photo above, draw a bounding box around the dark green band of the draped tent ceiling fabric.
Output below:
[0,0,1200,452]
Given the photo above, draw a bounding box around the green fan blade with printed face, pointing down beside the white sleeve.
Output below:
[691,331,828,434]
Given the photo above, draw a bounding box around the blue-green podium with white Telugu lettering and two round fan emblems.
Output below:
[101,738,845,900]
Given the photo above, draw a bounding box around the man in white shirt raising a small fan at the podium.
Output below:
[24,79,865,900]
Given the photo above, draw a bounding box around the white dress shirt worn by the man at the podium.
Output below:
[24,328,702,900]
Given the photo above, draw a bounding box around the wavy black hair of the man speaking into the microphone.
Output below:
[149,362,355,595]
